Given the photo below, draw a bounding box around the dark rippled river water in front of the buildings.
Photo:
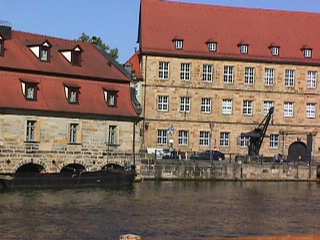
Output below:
[0,182,320,240]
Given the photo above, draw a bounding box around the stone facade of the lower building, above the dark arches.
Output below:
[0,113,139,173]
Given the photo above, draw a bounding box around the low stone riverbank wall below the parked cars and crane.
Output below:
[138,161,319,181]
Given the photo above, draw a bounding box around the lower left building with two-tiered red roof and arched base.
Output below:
[0,26,139,173]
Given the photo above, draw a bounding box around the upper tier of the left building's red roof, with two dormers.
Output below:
[0,31,130,82]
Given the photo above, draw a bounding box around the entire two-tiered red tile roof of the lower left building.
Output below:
[0,31,138,121]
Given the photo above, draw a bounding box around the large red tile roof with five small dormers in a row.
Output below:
[139,0,320,65]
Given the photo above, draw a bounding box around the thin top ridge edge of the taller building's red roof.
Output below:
[159,0,320,16]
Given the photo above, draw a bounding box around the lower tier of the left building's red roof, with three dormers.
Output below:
[0,71,137,118]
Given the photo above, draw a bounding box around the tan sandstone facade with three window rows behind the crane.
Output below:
[141,55,320,158]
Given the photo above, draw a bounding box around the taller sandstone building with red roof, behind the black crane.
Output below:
[130,0,320,159]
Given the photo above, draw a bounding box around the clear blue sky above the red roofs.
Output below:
[0,0,320,63]
